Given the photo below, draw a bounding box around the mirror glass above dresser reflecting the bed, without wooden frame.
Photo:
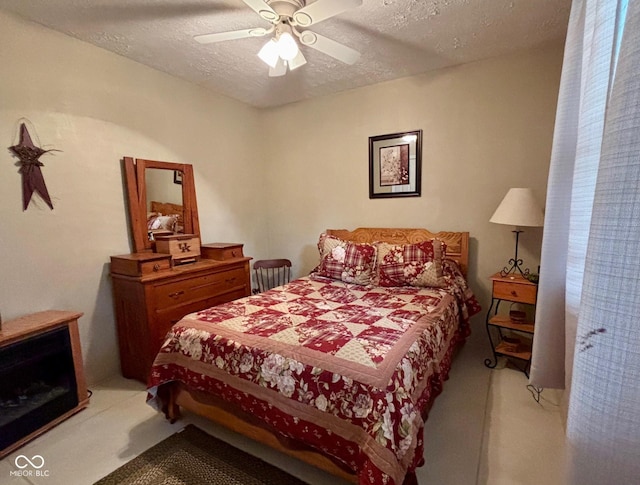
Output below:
[144,168,184,241]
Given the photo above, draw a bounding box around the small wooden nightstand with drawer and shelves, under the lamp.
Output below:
[484,273,538,377]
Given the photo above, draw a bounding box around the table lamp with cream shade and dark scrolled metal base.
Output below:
[489,188,544,277]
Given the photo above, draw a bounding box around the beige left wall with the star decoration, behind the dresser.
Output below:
[0,12,266,382]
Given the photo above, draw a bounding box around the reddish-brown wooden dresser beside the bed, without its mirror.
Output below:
[111,243,251,383]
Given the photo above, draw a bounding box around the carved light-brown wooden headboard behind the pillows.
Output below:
[326,227,469,276]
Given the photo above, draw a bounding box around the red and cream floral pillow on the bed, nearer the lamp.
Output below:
[376,239,447,288]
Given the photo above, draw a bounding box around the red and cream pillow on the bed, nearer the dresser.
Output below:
[316,234,376,285]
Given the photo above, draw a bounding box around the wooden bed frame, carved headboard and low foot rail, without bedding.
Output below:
[158,228,469,485]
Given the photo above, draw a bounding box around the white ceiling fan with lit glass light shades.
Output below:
[194,0,362,77]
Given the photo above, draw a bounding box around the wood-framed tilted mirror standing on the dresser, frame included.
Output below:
[124,157,200,253]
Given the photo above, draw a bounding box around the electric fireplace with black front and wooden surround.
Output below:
[0,311,88,457]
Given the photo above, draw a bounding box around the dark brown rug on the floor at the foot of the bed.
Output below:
[95,425,305,485]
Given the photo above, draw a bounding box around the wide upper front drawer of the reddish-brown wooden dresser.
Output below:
[154,268,246,310]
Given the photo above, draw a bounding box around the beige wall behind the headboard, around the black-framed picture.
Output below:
[263,46,562,307]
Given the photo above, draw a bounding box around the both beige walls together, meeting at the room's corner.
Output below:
[0,8,561,382]
